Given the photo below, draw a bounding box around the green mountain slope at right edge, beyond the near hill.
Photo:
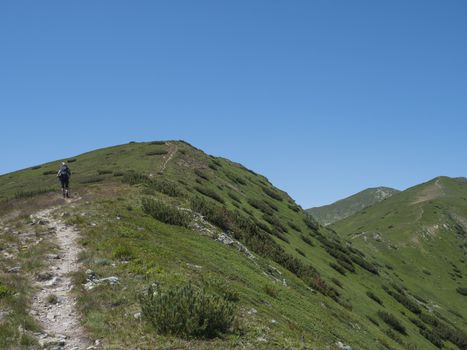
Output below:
[332,177,467,350]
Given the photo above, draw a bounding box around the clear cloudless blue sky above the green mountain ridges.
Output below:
[0,0,467,207]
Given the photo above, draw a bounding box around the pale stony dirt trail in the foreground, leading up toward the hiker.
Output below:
[31,208,90,350]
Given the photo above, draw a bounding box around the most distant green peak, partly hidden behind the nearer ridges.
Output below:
[306,187,399,225]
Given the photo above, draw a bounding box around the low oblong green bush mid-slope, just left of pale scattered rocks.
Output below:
[142,198,191,227]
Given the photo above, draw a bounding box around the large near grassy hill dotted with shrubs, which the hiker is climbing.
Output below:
[0,141,465,349]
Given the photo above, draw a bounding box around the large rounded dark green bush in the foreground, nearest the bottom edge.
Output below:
[140,284,235,338]
